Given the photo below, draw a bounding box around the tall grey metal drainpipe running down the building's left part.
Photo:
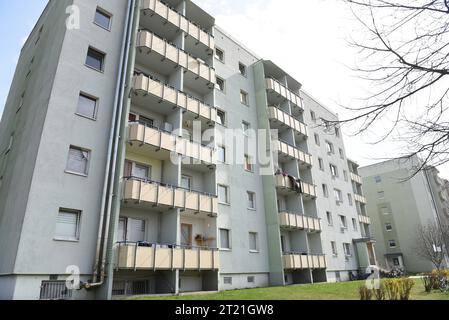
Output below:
[83,0,136,289]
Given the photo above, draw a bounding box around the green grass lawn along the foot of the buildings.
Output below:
[132,279,449,300]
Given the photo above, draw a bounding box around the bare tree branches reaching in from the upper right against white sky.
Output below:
[327,0,449,171]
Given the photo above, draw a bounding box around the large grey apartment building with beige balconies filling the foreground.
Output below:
[0,0,376,299]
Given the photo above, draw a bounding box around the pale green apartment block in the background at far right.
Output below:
[360,157,448,272]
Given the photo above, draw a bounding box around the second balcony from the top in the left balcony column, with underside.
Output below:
[136,31,216,94]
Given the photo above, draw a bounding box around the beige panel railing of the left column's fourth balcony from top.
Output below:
[128,122,217,164]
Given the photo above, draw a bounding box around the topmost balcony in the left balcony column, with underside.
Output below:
[141,0,215,52]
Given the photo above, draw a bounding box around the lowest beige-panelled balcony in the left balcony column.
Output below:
[115,242,220,271]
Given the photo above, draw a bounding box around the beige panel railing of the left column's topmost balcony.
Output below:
[142,0,215,50]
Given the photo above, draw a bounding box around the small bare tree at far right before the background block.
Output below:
[416,223,448,269]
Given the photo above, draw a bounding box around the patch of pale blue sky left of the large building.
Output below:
[0,0,47,116]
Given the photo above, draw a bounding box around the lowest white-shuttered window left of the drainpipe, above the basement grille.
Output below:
[55,209,81,241]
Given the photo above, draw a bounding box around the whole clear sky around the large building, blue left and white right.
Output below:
[0,0,449,178]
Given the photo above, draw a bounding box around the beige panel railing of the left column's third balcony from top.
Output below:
[133,74,217,122]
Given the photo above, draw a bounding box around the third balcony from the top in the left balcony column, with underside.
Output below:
[133,74,217,123]
